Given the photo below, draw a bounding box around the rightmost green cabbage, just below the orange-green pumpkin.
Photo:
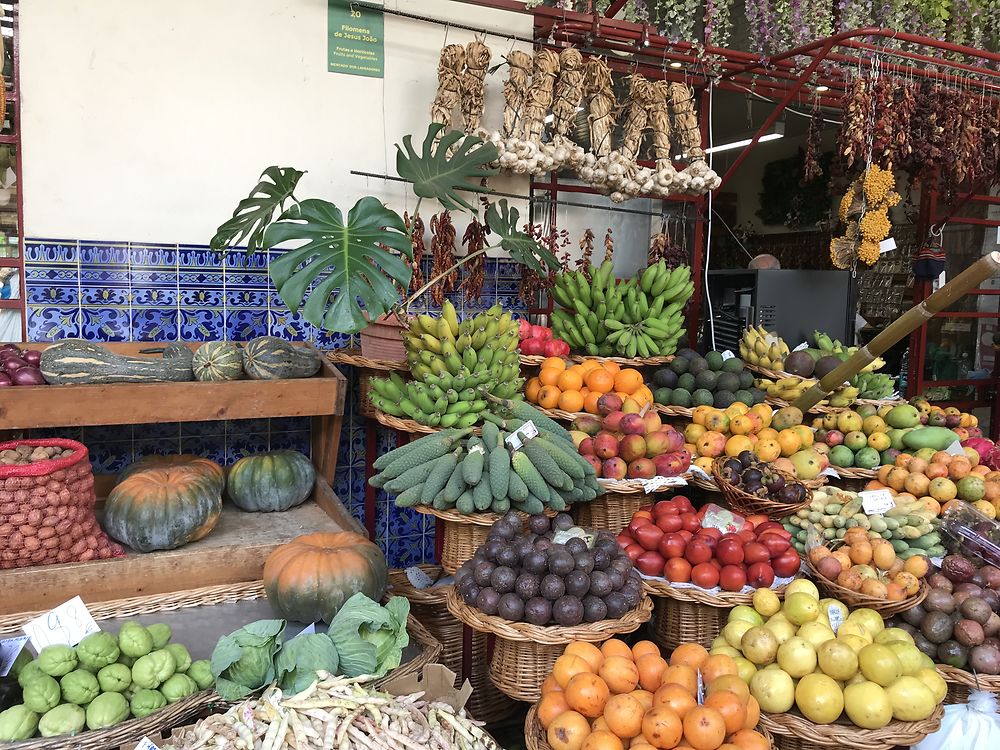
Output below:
[329,591,410,677]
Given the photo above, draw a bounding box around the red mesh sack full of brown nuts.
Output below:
[0,438,125,570]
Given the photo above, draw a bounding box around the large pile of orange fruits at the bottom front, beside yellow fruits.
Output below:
[536,638,771,750]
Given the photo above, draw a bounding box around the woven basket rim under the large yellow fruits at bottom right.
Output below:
[760,705,944,750]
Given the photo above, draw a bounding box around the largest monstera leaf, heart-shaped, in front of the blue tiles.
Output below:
[264,196,413,333]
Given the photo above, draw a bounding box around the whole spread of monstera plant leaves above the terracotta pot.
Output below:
[211,123,559,333]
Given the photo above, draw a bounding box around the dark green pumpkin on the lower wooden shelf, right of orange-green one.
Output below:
[226,450,316,512]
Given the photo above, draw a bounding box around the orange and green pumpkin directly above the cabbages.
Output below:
[263,531,389,623]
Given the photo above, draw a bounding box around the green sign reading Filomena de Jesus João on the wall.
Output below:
[326,0,385,78]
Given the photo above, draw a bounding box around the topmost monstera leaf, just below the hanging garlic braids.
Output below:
[396,122,499,213]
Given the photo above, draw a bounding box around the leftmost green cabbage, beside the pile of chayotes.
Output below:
[211,620,285,701]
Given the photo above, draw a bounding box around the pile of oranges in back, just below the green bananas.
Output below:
[524,357,653,414]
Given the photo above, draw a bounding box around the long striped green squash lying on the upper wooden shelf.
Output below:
[39,339,194,385]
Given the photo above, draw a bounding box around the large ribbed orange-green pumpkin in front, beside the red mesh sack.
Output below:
[104,464,223,552]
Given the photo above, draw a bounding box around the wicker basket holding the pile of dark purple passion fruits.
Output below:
[448,588,653,701]
